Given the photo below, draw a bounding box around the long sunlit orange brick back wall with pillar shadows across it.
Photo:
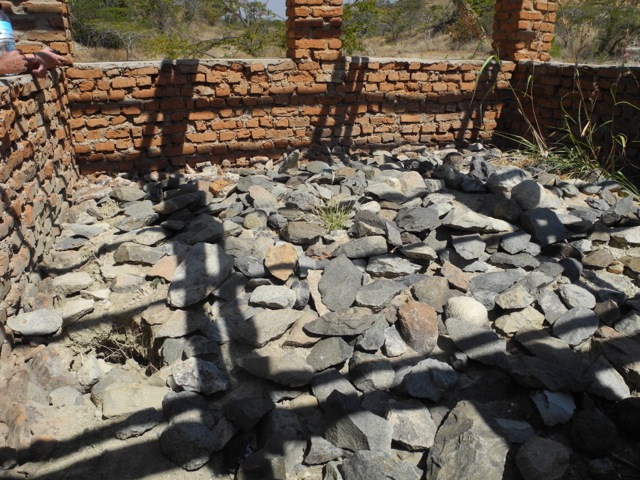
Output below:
[67,59,513,172]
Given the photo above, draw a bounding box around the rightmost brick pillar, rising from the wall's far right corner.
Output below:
[493,0,558,62]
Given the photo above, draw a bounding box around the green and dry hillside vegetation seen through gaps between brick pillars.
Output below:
[70,0,640,63]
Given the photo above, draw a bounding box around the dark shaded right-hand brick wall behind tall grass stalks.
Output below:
[498,62,640,159]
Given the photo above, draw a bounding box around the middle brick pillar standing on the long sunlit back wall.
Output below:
[287,0,343,61]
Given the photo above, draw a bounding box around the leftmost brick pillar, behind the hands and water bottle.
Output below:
[0,0,73,54]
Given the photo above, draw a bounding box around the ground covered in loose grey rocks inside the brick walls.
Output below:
[0,145,640,480]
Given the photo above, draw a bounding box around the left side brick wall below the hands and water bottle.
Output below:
[0,72,76,316]
